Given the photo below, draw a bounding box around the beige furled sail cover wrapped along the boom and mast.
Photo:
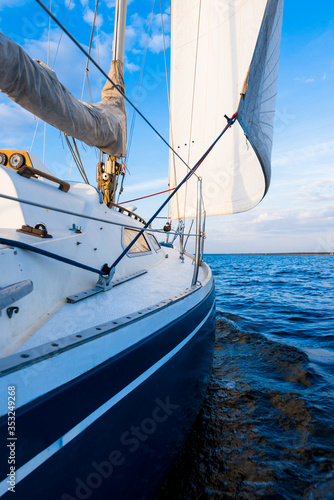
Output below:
[0,33,126,157]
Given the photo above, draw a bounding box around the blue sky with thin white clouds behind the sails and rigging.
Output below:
[0,0,334,253]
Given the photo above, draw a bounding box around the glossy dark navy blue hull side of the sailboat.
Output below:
[0,289,215,500]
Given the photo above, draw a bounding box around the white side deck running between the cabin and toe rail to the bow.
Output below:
[18,248,205,352]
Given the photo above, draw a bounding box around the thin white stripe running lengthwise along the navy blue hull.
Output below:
[0,293,214,495]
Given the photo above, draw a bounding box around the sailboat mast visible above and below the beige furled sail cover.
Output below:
[97,0,127,205]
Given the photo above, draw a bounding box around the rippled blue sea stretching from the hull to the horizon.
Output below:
[158,255,334,500]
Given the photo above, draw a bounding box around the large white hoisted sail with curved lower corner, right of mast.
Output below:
[169,0,283,219]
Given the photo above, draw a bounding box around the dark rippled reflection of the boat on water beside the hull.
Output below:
[157,313,334,500]
